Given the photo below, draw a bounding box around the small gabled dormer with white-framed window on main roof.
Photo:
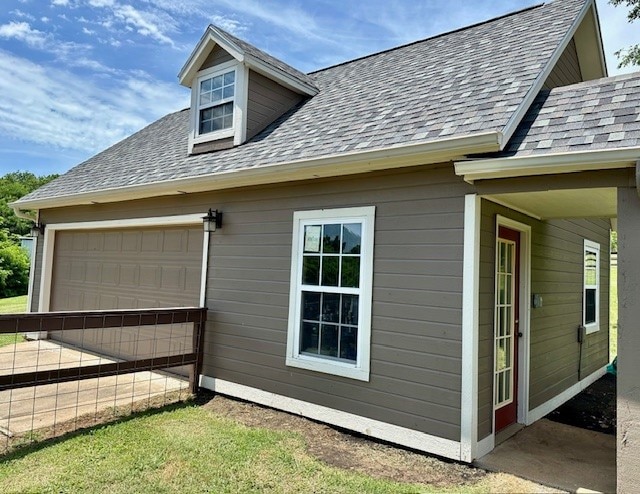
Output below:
[178,26,318,154]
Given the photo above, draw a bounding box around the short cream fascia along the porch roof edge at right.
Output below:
[454,147,640,183]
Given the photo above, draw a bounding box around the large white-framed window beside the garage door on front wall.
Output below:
[286,206,375,381]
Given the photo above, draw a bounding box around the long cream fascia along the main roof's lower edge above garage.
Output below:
[10,132,502,210]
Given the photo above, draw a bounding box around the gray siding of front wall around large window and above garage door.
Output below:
[42,164,470,440]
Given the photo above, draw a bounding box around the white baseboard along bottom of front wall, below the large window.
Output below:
[200,375,460,460]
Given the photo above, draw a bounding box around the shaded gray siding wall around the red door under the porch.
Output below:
[478,200,610,439]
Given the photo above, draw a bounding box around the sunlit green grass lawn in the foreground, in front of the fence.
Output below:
[0,405,468,494]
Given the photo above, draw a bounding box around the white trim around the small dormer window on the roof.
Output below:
[189,60,249,153]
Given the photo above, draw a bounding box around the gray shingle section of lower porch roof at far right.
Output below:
[501,72,640,156]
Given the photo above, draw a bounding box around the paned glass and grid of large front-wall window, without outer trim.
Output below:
[299,221,362,363]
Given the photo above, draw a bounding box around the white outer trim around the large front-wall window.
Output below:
[286,206,375,381]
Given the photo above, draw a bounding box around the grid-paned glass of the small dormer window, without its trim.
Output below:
[198,70,236,134]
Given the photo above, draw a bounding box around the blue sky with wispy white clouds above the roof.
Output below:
[0,0,640,175]
